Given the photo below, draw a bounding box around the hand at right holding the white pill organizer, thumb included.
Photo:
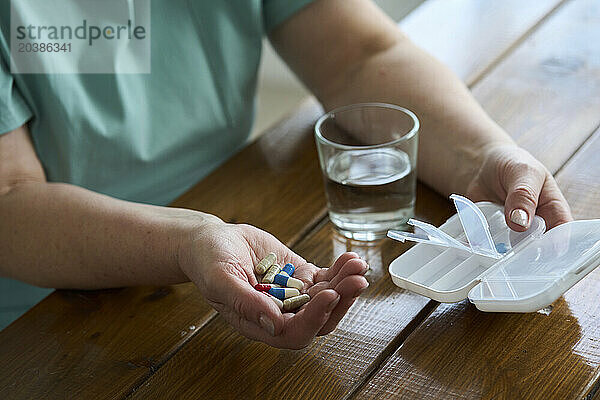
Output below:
[467,144,573,232]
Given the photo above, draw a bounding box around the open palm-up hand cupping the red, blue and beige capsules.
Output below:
[179,222,369,349]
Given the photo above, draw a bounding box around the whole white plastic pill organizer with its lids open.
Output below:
[388,195,600,312]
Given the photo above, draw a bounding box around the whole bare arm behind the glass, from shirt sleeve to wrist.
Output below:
[269,0,512,193]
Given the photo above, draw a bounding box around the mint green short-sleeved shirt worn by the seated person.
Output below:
[0,0,311,329]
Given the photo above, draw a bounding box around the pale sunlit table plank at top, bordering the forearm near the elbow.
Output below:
[400,0,563,85]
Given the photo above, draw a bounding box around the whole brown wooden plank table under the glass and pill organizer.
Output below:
[0,0,600,399]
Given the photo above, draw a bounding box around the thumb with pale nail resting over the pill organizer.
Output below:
[503,164,546,232]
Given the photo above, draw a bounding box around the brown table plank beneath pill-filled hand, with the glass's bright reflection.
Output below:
[132,185,452,399]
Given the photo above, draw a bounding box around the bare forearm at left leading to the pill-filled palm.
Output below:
[0,182,218,289]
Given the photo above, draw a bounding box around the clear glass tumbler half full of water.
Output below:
[315,103,419,240]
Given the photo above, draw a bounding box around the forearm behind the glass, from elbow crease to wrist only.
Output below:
[320,37,512,194]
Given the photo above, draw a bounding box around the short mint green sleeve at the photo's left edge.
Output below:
[0,54,33,135]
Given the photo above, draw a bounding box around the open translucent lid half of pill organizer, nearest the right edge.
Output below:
[468,219,600,312]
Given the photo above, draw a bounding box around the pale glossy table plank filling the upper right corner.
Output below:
[473,0,600,173]
